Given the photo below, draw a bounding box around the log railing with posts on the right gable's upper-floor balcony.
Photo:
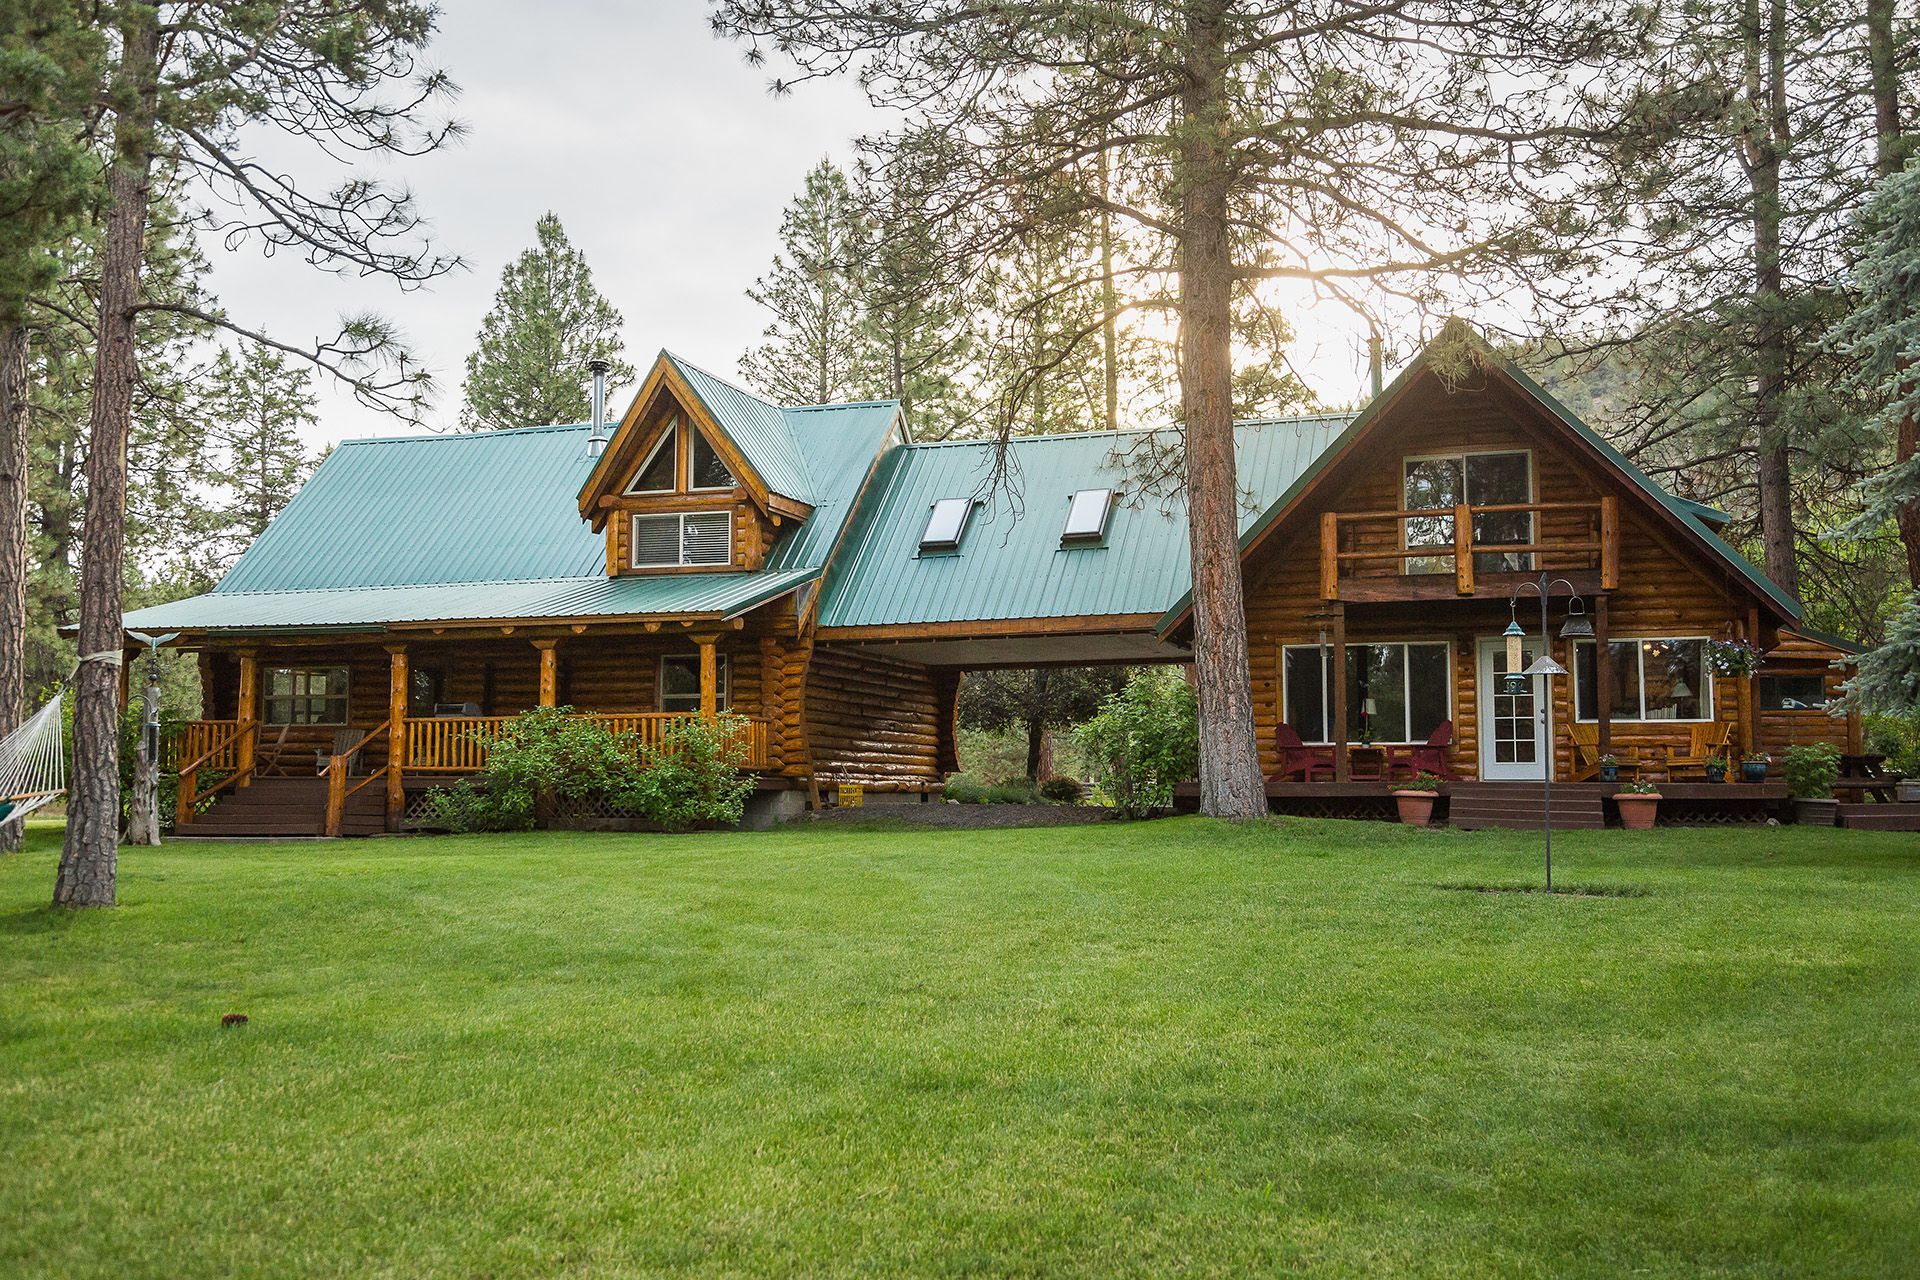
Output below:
[1319,495,1620,601]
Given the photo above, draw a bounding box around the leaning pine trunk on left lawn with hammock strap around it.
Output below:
[54,4,157,906]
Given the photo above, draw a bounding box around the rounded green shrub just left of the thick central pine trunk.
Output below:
[1079,668,1200,818]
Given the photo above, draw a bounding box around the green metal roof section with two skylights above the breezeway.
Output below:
[820,416,1346,628]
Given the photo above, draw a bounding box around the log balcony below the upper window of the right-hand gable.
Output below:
[1319,495,1620,603]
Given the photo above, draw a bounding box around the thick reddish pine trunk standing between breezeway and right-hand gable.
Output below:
[1177,0,1267,818]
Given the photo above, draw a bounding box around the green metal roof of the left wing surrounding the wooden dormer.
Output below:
[125,391,899,629]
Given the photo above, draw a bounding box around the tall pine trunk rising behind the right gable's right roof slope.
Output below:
[1745,0,1799,595]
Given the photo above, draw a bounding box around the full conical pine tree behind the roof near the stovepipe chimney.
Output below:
[461,213,634,432]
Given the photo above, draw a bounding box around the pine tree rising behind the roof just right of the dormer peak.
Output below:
[739,159,879,405]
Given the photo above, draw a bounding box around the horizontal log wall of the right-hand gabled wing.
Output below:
[1246,379,1766,777]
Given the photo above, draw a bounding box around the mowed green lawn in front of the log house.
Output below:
[0,819,1920,1278]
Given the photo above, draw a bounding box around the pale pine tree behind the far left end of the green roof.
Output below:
[202,345,319,560]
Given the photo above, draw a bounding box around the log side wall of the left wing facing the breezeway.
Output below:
[804,645,952,791]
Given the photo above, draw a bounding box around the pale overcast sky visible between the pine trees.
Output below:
[207,0,1363,443]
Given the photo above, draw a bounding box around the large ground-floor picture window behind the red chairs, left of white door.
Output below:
[1281,641,1453,743]
